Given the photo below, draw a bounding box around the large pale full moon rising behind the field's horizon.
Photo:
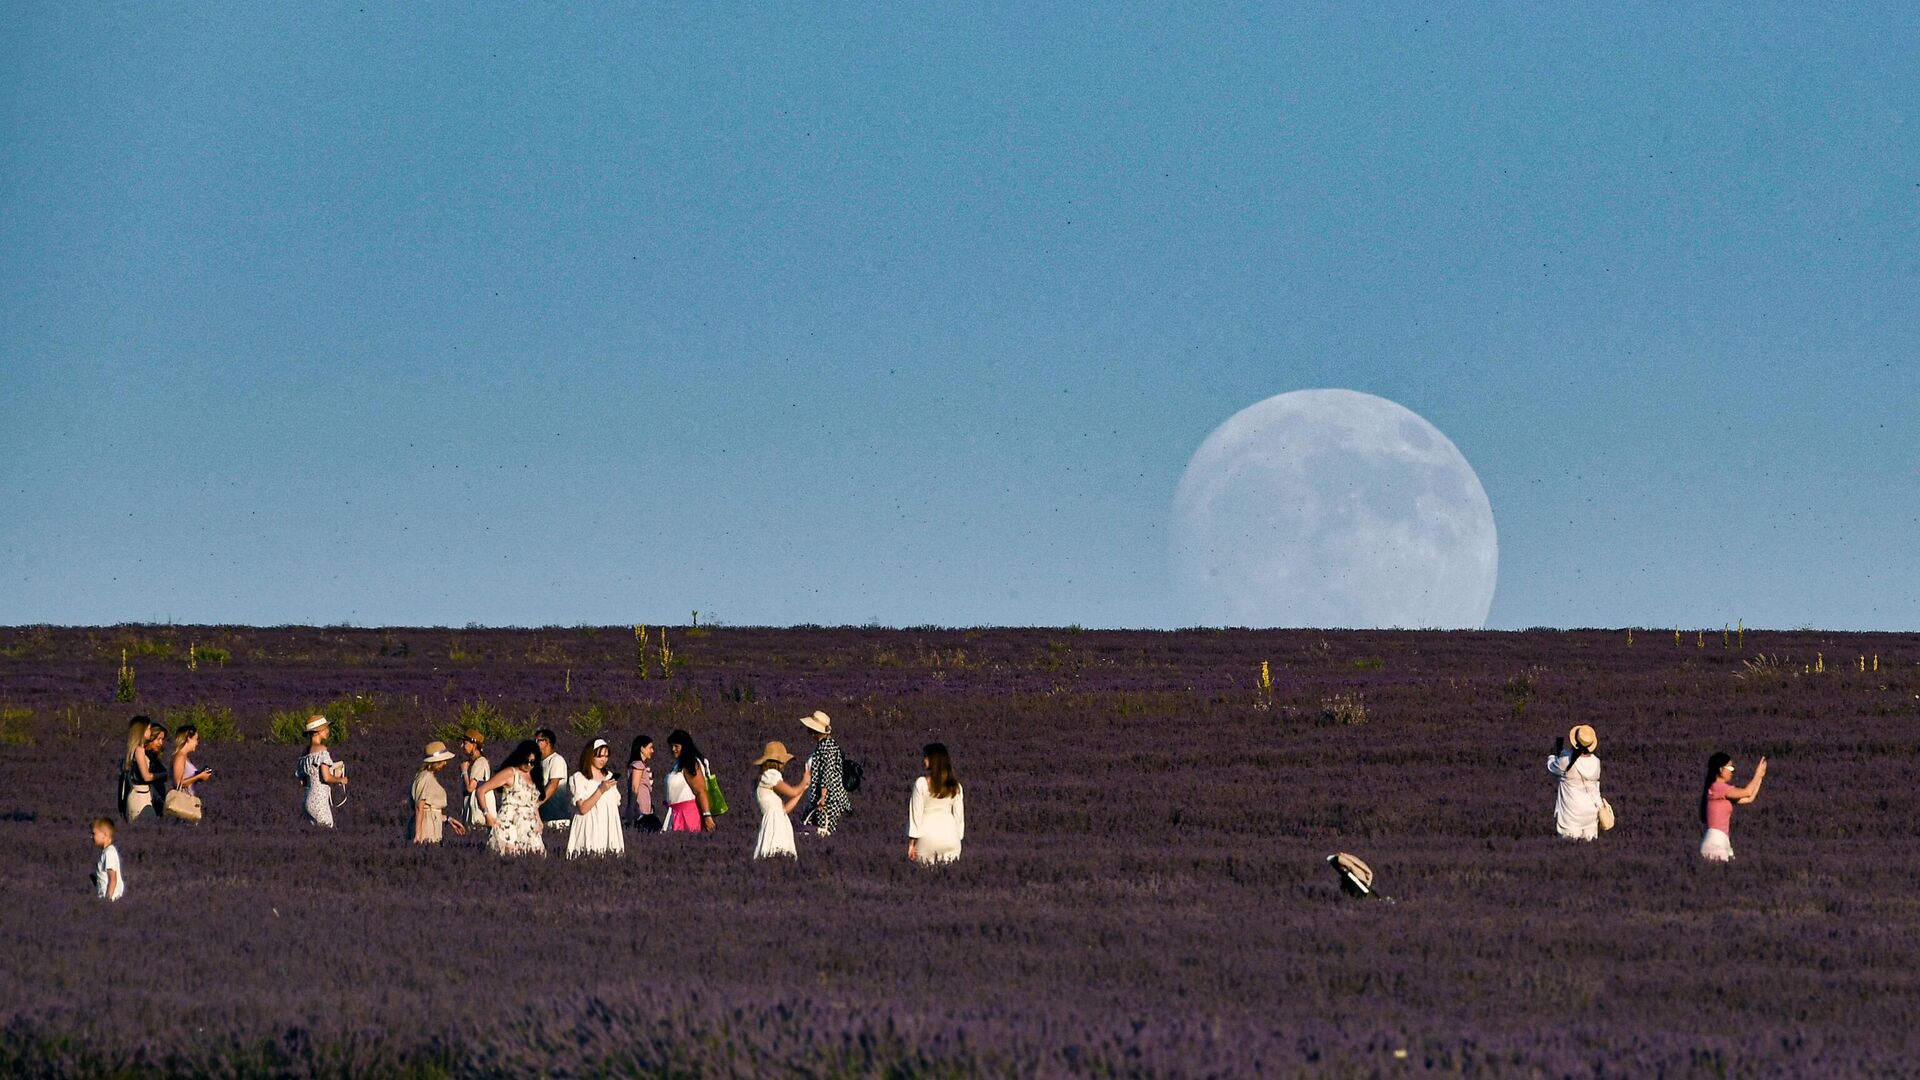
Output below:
[1173,390,1500,630]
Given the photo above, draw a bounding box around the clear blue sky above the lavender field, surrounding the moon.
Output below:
[0,4,1920,628]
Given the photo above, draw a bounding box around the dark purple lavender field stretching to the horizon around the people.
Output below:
[0,626,1920,1076]
